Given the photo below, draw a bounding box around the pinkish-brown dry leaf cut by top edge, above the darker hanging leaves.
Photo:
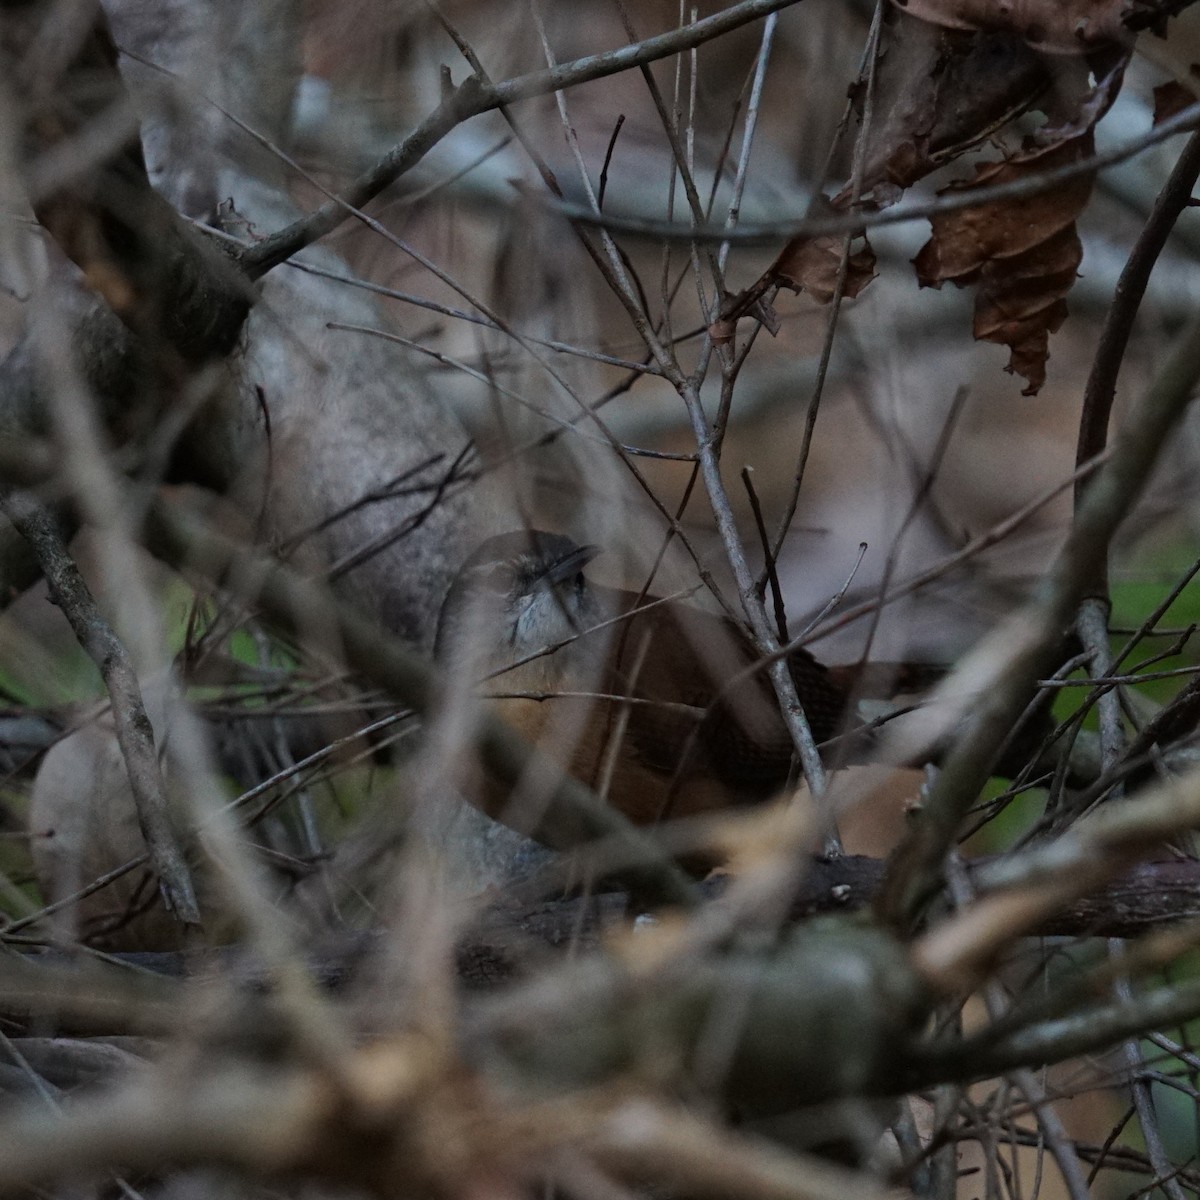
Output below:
[893,0,1134,54]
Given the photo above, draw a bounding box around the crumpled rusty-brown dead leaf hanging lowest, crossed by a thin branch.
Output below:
[913,132,1093,396]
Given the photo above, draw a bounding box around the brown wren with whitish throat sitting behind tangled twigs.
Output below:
[434,529,860,824]
